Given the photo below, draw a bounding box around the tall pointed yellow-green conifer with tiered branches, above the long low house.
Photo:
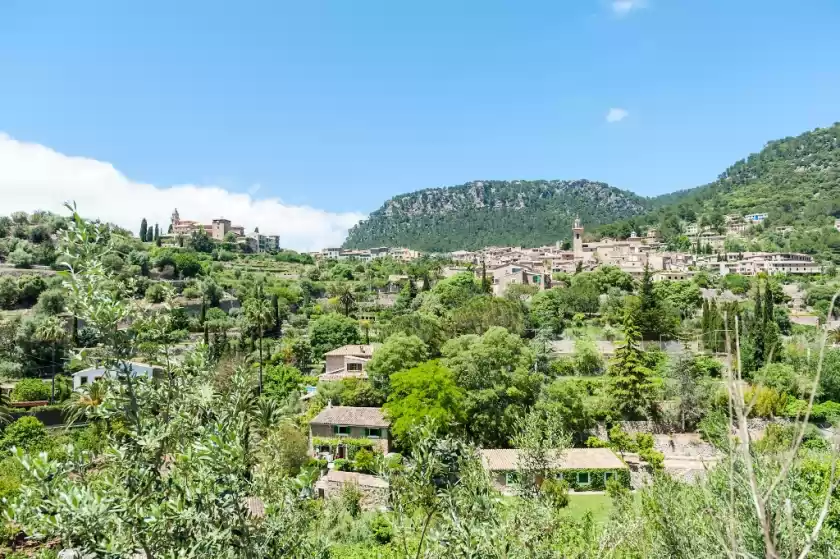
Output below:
[607,313,658,419]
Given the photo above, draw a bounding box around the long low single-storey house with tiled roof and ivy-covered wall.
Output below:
[479,448,630,494]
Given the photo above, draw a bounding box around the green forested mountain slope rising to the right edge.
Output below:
[599,123,840,246]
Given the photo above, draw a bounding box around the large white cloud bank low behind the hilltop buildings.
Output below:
[0,133,366,250]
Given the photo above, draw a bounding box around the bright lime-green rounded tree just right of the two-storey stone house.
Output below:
[383,361,464,444]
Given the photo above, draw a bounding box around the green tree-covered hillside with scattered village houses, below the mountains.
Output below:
[0,206,840,552]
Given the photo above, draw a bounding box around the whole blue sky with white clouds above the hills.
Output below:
[0,0,840,250]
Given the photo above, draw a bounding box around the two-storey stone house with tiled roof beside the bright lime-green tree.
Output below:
[309,405,391,458]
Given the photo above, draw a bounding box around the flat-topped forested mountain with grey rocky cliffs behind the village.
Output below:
[344,180,651,251]
